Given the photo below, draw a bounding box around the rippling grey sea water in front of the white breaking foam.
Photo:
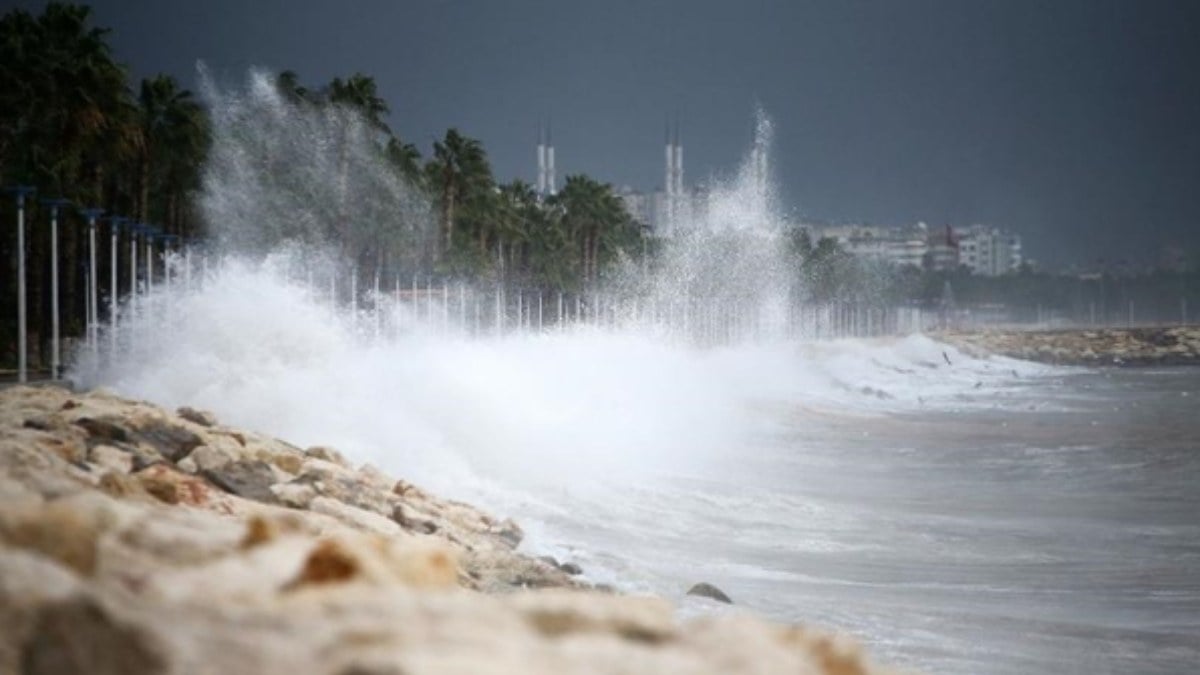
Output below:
[513,369,1200,674]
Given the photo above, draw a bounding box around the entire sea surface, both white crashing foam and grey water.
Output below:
[74,263,1200,674]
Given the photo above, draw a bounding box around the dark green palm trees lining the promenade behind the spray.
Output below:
[0,2,649,363]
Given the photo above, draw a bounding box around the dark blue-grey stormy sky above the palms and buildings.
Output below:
[11,0,1200,265]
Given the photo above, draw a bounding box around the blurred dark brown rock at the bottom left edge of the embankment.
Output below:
[20,596,167,675]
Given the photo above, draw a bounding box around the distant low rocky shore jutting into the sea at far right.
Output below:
[935,325,1200,366]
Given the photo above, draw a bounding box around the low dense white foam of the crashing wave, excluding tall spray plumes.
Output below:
[76,255,1036,499]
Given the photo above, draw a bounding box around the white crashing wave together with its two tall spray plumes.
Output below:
[74,71,1041,504]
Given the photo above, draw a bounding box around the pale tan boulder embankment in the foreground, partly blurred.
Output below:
[0,387,902,675]
